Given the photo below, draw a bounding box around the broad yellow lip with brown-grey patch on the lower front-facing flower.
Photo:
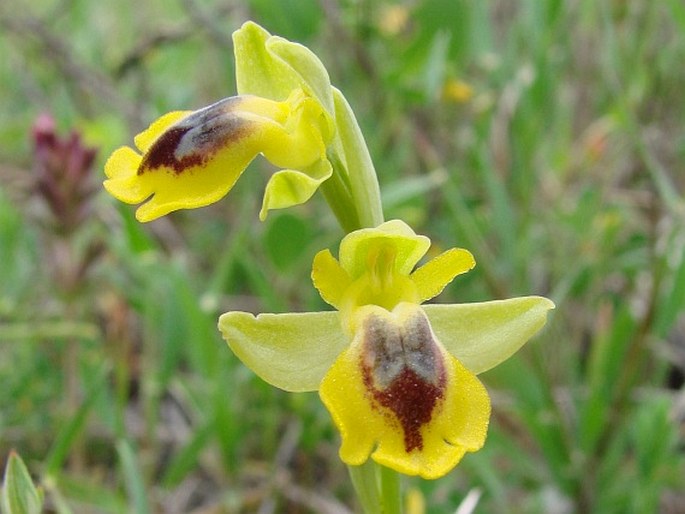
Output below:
[319,303,490,479]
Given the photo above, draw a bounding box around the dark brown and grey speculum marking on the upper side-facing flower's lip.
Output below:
[138,97,252,175]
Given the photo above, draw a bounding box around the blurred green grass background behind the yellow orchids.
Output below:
[0,0,685,514]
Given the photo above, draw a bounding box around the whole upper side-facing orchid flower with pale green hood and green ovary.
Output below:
[104,22,383,231]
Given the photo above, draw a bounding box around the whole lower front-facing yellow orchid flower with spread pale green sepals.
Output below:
[219,220,554,479]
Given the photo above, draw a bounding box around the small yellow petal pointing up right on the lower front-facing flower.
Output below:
[411,248,476,302]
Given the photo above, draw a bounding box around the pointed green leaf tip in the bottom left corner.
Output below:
[2,452,43,514]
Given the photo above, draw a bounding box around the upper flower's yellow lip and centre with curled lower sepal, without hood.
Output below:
[104,89,334,221]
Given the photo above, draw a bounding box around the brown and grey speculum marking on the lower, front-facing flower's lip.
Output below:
[361,306,446,453]
